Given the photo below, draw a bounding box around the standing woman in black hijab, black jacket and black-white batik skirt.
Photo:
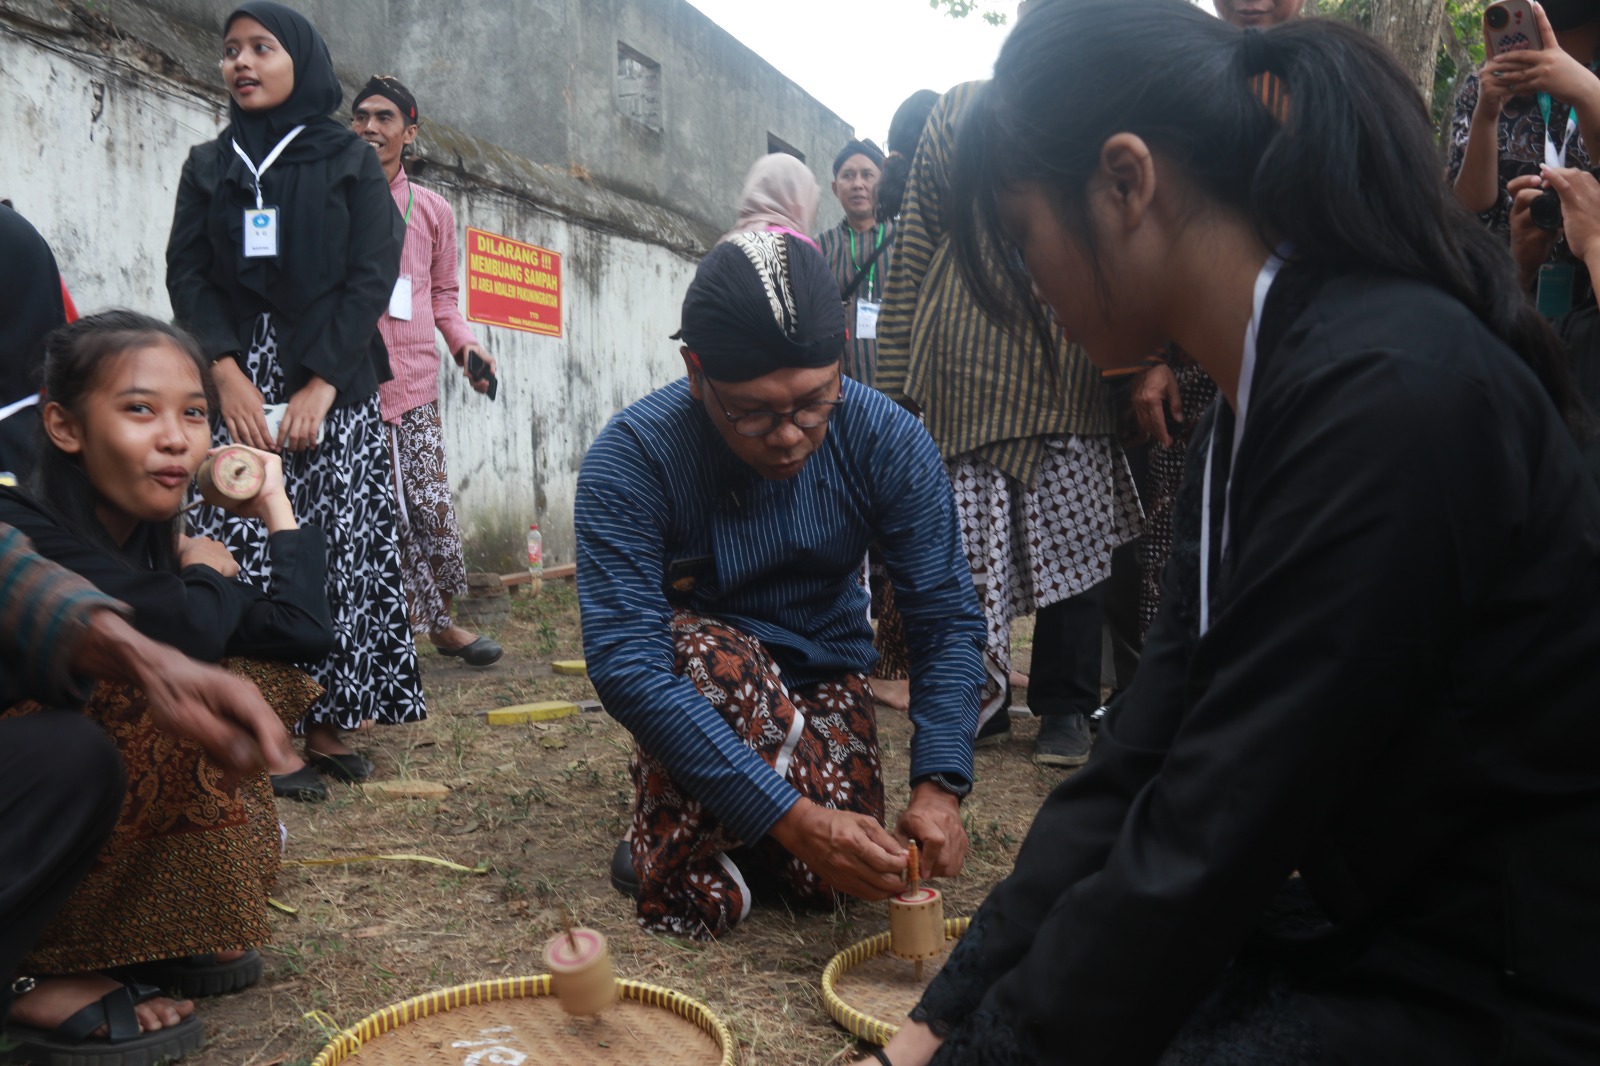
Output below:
[166,0,424,799]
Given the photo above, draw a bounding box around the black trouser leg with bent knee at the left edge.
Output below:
[0,711,128,1018]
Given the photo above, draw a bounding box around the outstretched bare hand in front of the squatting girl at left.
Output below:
[72,610,294,776]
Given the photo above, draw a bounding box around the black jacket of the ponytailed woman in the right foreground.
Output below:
[917,267,1600,1066]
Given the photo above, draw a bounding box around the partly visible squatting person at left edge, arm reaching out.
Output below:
[0,525,290,1040]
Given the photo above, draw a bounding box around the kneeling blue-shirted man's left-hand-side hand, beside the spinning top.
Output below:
[771,797,908,900]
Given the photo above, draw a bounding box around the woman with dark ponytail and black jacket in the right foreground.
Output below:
[886,0,1600,1066]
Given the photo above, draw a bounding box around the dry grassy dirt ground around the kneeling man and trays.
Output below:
[186,581,1062,1066]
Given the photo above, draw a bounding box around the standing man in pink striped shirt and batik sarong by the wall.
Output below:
[350,75,502,666]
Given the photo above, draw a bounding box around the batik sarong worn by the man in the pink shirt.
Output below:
[389,402,467,632]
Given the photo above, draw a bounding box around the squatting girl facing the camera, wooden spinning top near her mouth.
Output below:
[0,311,333,1063]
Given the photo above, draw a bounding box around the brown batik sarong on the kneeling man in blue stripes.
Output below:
[629,611,883,940]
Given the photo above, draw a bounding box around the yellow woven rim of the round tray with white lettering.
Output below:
[310,973,738,1066]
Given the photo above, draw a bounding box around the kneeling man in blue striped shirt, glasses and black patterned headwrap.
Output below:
[576,232,984,936]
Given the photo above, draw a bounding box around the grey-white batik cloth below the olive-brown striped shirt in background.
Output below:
[947,437,1142,722]
